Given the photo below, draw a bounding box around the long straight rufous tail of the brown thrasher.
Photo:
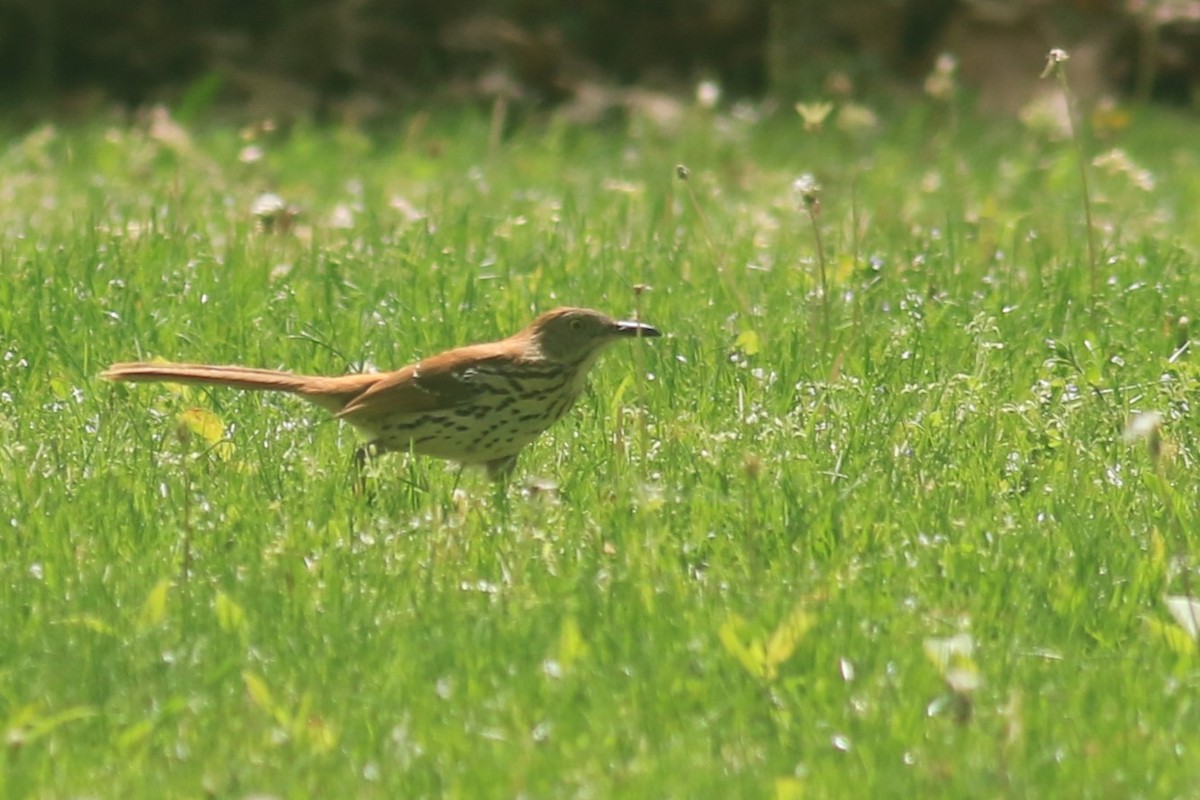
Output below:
[101,361,378,413]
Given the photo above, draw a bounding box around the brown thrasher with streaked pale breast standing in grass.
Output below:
[102,308,660,480]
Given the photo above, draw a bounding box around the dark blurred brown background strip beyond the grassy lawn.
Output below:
[0,0,1200,121]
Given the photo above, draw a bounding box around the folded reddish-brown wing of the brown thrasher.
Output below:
[337,348,501,425]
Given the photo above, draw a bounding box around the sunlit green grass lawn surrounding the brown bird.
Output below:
[0,101,1200,800]
